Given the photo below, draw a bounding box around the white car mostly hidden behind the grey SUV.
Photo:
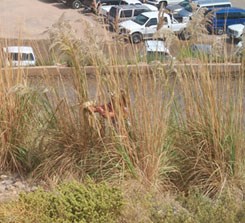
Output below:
[99,0,158,17]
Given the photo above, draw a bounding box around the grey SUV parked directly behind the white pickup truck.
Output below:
[108,5,155,27]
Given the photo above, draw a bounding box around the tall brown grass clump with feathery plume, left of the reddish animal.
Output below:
[31,17,111,180]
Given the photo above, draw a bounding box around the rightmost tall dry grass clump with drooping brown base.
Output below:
[172,71,244,195]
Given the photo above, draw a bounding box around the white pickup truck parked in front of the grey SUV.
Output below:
[119,11,189,43]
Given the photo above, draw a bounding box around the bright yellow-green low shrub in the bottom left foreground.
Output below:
[3,182,123,223]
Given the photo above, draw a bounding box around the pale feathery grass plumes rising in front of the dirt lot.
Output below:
[47,14,107,69]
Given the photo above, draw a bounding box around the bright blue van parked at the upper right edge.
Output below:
[207,7,245,35]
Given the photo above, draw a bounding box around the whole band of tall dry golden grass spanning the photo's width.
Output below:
[0,11,244,195]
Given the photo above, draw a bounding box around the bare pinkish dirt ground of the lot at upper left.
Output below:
[0,0,245,39]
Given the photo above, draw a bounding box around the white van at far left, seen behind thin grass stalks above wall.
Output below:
[3,46,36,66]
